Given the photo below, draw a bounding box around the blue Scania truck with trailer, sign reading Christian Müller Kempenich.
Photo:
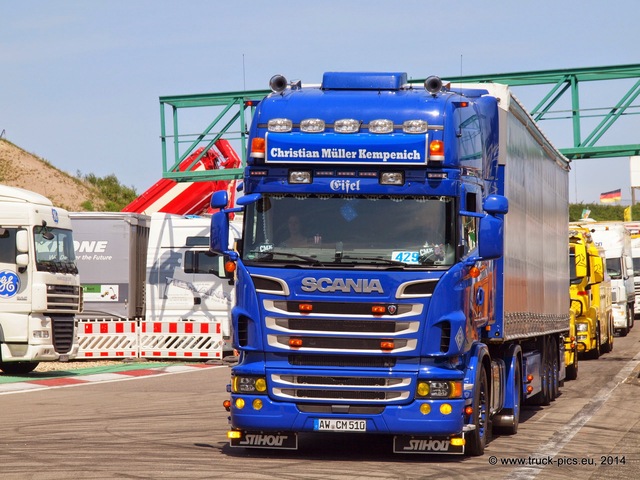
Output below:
[211,72,569,455]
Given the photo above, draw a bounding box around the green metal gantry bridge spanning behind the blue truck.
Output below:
[160,64,640,182]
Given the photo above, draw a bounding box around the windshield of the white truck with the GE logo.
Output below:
[33,226,78,273]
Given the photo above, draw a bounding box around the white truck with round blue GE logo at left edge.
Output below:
[0,185,82,374]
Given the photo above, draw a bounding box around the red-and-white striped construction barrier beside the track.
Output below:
[76,318,224,360]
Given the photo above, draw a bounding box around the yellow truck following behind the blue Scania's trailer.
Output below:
[569,224,614,358]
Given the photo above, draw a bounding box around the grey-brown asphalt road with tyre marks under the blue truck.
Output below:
[0,326,640,480]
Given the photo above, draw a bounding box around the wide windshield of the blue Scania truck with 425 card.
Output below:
[243,195,455,268]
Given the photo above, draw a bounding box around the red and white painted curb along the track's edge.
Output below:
[0,364,223,395]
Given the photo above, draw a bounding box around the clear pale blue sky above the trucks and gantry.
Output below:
[0,0,640,204]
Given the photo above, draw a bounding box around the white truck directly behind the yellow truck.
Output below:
[571,221,635,337]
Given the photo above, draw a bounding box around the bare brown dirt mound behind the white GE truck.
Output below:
[0,139,105,212]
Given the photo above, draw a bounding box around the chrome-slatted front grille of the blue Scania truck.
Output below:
[263,292,428,404]
